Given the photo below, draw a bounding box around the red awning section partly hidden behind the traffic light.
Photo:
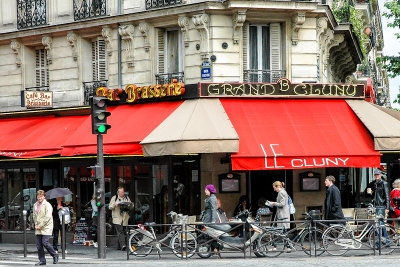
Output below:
[61,101,182,156]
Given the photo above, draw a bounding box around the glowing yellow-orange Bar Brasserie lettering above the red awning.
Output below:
[96,79,185,103]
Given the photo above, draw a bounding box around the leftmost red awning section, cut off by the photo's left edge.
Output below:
[0,116,87,158]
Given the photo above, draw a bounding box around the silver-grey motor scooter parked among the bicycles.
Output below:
[197,210,265,258]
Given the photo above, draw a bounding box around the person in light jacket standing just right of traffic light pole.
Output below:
[108,187,133,250]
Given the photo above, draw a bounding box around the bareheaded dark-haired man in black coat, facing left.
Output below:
[325,175,344,224]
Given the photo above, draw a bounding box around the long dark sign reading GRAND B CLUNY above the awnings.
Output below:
[199,78,365,98]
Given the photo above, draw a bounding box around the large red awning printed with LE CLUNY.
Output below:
[221,99,380,170]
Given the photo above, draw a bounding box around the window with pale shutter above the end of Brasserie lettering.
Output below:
[156,29,184,84]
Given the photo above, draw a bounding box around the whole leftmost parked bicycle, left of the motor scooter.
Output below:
[128,212,197,258]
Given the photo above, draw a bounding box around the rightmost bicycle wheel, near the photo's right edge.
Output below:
[368,224,400,254]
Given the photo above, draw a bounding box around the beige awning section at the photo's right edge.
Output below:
[346,100,400,151]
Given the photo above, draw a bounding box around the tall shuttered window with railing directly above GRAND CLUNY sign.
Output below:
[243,23,285,82]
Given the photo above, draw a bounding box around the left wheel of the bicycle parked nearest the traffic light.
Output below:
[129,230,153,257]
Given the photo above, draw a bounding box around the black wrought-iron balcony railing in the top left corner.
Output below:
[17,0,47,30]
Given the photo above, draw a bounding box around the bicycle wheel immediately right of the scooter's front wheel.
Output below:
[254,231,285,258]
